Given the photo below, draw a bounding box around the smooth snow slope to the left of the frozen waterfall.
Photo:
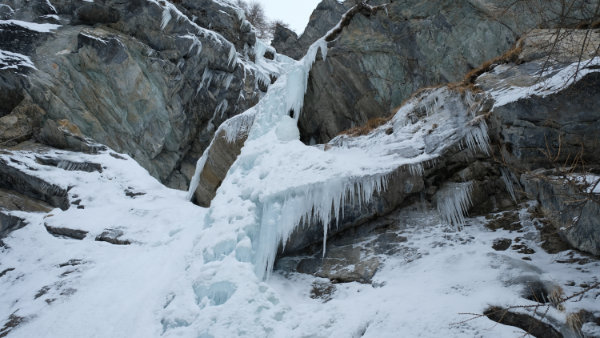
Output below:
[0,145,205,337]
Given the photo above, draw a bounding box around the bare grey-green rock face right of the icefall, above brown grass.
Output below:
[298,0,584,144]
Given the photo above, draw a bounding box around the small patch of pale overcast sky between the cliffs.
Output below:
[258,0,321,34]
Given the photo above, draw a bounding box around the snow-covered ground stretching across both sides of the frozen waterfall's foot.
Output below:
[0,151,600,338]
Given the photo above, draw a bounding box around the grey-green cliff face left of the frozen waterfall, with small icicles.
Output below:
[0,0,274,189]
